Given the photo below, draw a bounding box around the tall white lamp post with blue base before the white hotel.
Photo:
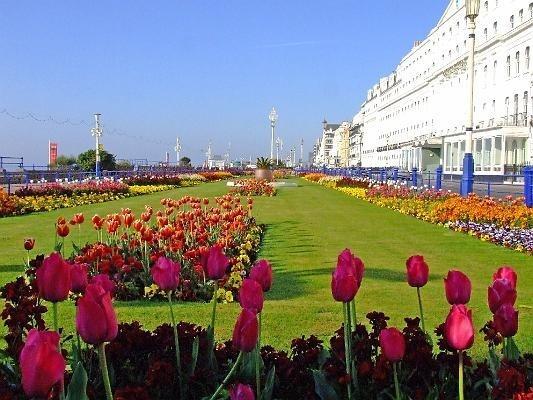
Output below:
[461,0,480,196]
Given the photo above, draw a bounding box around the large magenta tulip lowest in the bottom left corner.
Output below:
[19,329,65,398]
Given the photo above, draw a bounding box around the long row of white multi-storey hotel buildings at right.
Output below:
[314,0,533,176]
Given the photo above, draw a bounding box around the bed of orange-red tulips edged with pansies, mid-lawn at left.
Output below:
[49,193,263,302]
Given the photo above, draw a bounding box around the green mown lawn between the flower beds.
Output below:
[0,180,533,356]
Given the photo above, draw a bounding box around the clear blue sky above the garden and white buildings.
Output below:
[0,0,448,163]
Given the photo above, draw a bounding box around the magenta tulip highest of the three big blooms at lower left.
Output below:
[36,253,71,303]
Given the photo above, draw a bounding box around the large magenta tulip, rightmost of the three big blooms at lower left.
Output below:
[76,284,118,345]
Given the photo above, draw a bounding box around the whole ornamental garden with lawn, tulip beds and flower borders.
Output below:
[0,171,533,400]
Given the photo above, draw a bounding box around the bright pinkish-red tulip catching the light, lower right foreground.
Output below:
[444,304,474,350]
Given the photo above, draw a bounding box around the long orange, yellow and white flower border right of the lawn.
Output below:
[304,174,533,255]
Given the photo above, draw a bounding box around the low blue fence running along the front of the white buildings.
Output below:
[298,166,533,207]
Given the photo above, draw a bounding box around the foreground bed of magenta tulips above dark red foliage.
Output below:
[0,249,533,400]
